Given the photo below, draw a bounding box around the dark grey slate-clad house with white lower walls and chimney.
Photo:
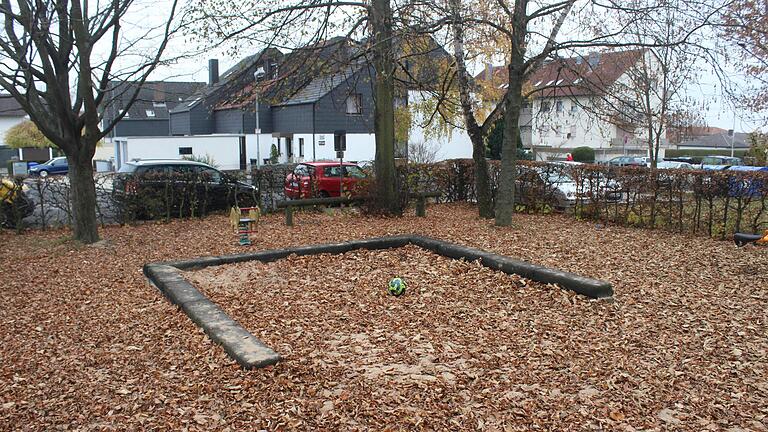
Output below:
[118,37,464,169]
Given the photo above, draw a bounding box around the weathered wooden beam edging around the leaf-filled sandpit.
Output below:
[144,235,613,369]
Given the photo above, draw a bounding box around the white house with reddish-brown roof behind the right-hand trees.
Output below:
[476,50,667,161]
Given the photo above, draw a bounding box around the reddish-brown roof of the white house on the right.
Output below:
[475,49,645,97]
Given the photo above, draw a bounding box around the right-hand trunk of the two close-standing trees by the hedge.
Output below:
[496,66,523,226]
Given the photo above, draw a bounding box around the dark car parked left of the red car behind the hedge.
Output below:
[114,159,257,217]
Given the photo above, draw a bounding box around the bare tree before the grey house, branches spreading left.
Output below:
[190,0,407,213]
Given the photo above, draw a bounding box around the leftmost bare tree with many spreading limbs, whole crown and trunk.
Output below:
[0,0,182,243]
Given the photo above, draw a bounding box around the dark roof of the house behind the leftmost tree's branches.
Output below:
[109,81,205,120]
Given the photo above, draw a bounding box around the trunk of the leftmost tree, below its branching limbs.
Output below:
[67,145,99,244]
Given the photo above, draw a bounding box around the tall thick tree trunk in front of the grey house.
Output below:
[370,0,400,214]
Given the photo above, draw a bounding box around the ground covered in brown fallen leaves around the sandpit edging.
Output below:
[0,205,768,431]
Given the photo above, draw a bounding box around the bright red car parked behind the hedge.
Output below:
[285,162,366,199]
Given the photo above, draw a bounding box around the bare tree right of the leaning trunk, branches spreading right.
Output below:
[449,0,725,226]
